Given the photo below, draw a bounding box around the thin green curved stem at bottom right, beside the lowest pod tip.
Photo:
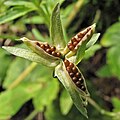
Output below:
[88,98,116,117]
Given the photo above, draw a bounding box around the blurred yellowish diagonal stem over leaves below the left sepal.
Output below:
[8,62,37,89]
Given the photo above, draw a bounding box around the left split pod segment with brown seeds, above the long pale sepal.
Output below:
[21,37,61,60]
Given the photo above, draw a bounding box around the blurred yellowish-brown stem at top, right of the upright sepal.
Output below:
[65,0,85,28]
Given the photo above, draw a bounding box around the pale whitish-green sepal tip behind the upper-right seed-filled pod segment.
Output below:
[86,33,100,49]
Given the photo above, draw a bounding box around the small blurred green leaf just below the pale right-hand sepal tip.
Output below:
[84,44,101,59]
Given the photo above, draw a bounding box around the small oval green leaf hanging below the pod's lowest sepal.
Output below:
[60,90,73,115]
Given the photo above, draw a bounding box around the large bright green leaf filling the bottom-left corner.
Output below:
[0,84,41,120]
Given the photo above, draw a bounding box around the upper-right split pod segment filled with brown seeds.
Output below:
[63,24,96,56]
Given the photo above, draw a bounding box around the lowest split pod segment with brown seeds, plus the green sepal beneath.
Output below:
[55,60,89,117]
